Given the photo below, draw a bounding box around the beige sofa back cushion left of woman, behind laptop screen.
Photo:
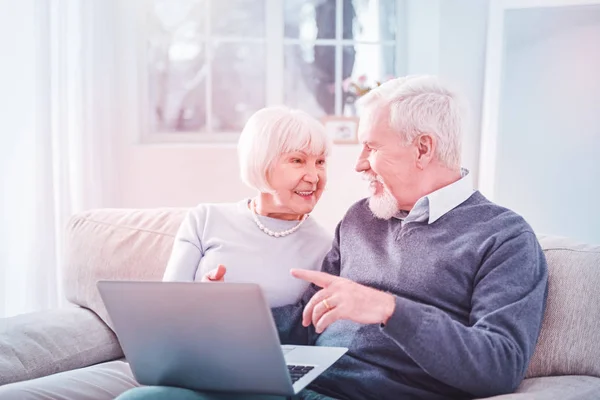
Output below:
[63,209,187,327]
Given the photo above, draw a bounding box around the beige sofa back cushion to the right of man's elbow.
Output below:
[527,236,600,377]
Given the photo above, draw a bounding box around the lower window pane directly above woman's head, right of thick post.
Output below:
[284,44,335,117]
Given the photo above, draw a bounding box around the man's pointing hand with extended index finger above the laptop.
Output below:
[291,269,396,333]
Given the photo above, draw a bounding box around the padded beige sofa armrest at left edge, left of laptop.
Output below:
[0,306,123,385]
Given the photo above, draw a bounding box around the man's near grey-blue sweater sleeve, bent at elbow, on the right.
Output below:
[381,232,548,397]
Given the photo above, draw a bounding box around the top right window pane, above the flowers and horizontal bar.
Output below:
[343,0,396,42]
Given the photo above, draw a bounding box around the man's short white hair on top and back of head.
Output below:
[360,75,466,169]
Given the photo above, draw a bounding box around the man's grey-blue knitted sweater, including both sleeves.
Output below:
[273,192,548,400]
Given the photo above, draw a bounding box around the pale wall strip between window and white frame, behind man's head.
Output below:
[406,0,489,182]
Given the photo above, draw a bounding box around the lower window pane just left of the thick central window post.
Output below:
[212,43,266,132]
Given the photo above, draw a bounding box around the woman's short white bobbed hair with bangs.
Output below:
[238,106,331,193]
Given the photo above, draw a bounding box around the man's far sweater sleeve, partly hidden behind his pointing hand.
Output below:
[271,222,341,345]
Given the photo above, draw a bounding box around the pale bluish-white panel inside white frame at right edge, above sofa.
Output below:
[494,6,600,243]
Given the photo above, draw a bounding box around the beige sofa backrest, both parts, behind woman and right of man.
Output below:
[63,209,600,377]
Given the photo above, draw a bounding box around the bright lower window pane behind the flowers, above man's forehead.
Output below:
[343,44,396,115]
